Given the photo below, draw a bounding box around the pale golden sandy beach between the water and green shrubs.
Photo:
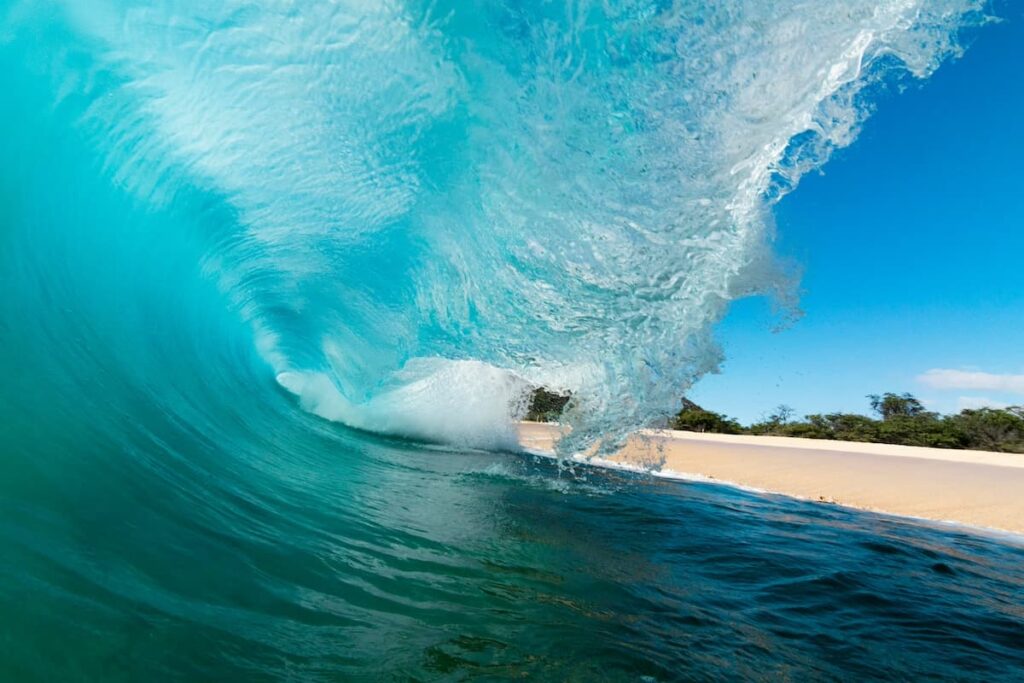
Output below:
[519,423,1024,533]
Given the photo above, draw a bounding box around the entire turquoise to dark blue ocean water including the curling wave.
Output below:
[0,0,1024,681]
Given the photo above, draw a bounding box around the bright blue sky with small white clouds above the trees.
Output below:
[690,3,1024,422]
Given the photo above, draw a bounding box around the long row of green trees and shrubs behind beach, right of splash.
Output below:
[672,393,1024,453]
